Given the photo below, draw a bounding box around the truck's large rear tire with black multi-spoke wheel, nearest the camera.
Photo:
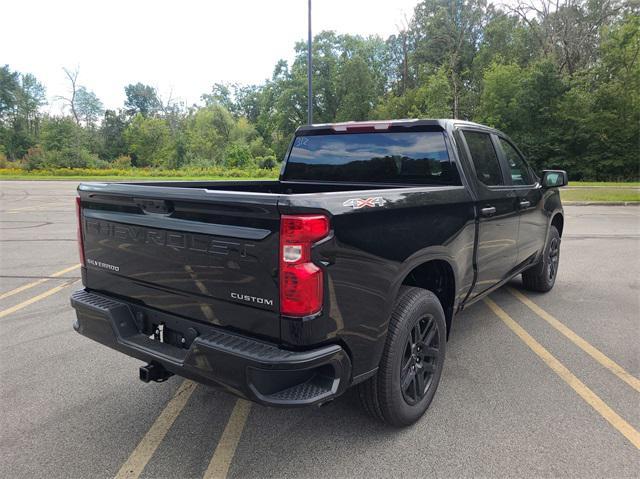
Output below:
[358,286,447,427]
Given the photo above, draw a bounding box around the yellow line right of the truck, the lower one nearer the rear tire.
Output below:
[484,298,640,449]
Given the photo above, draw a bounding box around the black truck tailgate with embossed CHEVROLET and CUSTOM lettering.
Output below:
[79,183,280,339]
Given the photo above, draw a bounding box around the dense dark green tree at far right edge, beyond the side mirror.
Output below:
[557,15,640,180]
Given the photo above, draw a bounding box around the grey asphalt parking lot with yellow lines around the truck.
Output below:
[0,182,640,478]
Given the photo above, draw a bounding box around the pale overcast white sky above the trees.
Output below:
[5,0,418,113]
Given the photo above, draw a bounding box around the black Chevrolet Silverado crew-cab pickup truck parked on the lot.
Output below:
[71,120,567,426]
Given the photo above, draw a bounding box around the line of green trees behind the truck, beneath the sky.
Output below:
[0,0,640,180]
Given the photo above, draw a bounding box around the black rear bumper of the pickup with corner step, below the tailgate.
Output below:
[71,290,351,407]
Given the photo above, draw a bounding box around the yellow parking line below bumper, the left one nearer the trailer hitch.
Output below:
[116,380,196,479]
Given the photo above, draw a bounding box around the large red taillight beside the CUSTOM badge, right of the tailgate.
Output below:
[280,215,329,317]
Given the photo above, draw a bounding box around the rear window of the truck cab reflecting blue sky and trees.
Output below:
[284,131,460,185]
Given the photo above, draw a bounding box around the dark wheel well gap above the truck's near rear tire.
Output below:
[402,260,456,338]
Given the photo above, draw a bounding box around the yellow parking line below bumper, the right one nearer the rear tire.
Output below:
[203,399,251,479]
